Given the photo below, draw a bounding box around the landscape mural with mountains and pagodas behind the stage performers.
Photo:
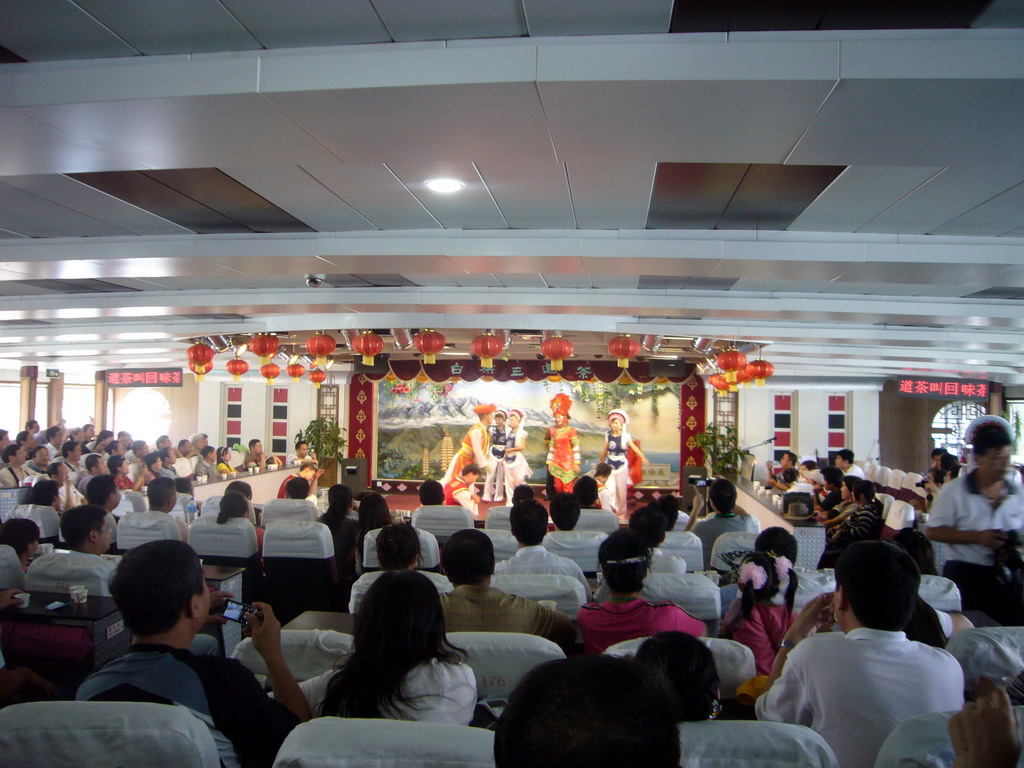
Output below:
[376,377,691,487]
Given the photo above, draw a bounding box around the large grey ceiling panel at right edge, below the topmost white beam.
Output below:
[787,79,1024,166]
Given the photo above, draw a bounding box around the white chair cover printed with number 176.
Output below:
[447,632,565,699]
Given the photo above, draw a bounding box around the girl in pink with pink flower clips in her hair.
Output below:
[723,552,798,675]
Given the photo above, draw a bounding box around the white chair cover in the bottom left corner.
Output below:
[0,701,220,768]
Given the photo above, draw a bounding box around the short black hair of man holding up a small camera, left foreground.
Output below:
[111,540,206,635]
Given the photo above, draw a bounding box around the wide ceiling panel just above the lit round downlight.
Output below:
[266,83,553,163]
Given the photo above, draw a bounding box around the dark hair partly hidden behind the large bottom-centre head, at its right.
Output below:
[636,632,721,723]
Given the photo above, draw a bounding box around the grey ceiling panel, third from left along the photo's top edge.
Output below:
[220,0,391,48]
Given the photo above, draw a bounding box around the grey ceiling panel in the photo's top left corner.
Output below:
[0,0,139,61]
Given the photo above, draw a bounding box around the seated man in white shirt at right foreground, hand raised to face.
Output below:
[756,542,964,768]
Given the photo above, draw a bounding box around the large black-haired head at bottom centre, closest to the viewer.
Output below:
[495,654,680,768]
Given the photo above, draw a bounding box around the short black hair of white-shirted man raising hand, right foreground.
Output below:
[836,542,921,632]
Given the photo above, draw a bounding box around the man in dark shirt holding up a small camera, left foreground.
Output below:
[77,540,309,766]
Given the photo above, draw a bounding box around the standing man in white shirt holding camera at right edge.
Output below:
[925,417,1024,627]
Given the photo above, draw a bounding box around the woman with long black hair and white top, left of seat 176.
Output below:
[301,573,476,725]
